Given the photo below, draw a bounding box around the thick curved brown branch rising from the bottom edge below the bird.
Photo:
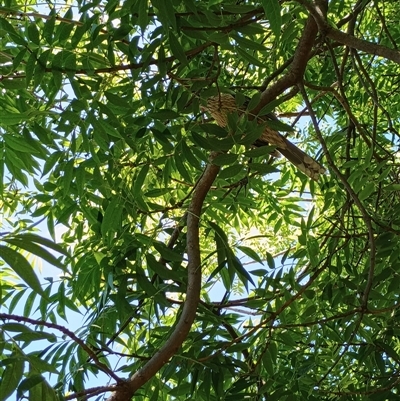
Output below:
[108,153,220,401]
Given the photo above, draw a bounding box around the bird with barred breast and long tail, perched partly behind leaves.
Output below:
[206,93,326,181]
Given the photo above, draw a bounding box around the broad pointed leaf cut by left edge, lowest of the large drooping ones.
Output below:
[0,245,44,295]
